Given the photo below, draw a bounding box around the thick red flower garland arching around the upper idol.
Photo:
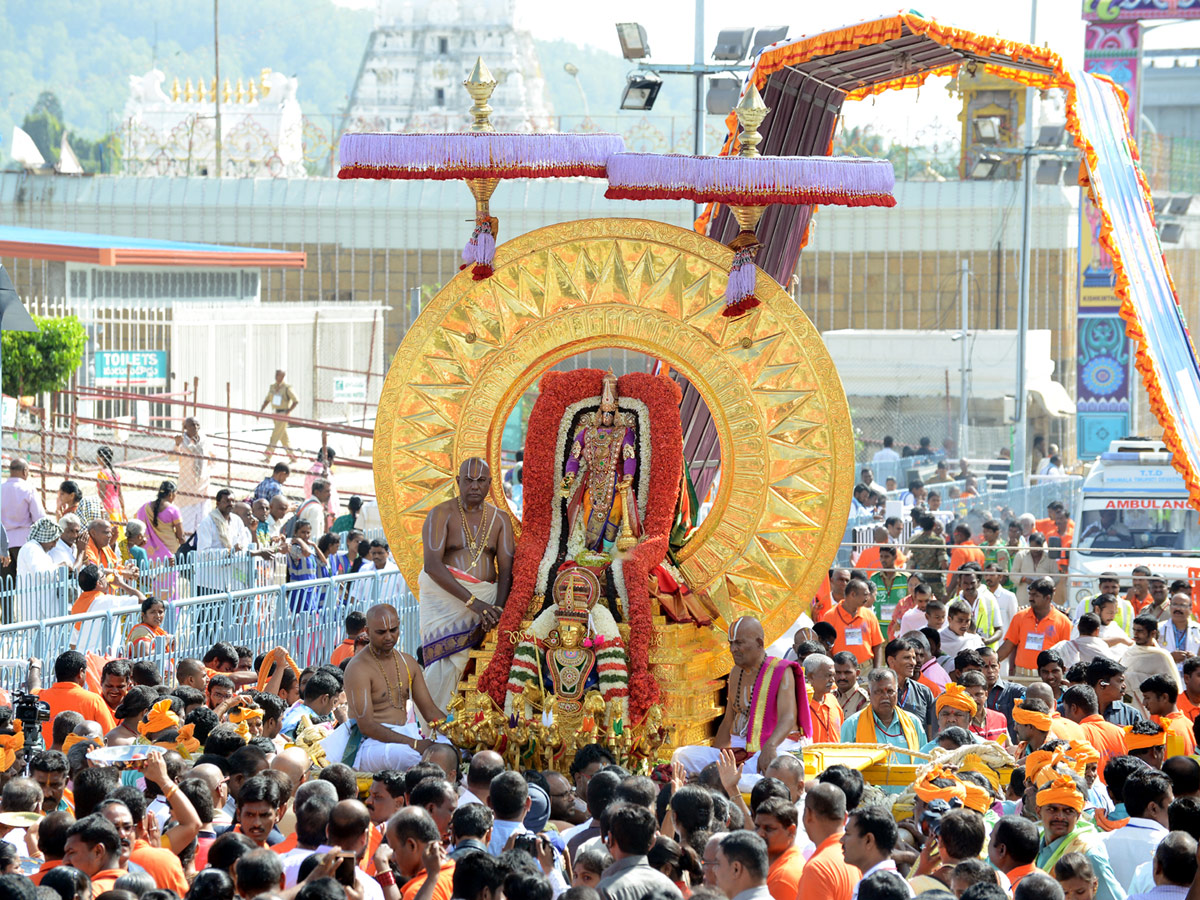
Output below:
[479,368,683,722]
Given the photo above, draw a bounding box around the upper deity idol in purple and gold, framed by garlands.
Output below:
[559,372,642,554]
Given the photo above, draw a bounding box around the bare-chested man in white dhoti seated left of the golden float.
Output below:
[322,604,445,772]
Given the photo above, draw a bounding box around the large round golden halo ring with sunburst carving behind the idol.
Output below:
[374,218,854,660]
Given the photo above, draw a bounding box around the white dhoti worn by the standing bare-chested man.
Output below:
[416,569,496,709]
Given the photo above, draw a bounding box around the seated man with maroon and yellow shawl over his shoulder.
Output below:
[672,616,812,791]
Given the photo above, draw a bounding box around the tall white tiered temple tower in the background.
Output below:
[343,0,552,132]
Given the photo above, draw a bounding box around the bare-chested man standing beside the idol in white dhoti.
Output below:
[416,457,515,708]
